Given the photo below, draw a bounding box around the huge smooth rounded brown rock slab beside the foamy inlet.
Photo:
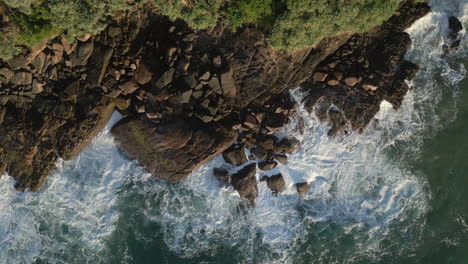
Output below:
[112,118,237,182]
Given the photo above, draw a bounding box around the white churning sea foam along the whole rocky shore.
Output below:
[0,0,468,264]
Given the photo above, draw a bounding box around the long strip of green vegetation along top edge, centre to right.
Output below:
[154,0,424,50]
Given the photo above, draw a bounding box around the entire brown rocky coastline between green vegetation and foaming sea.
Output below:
[0,1,434,204]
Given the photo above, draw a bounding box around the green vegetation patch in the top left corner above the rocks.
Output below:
[0,0,134,58]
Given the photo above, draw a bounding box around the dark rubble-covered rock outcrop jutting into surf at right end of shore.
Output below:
[303,2,430,136]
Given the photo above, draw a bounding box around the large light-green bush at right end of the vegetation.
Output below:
[271,0,401,50]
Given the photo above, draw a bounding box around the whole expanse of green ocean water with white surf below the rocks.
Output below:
[0,0,468,264]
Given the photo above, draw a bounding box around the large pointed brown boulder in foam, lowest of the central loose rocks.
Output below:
[231,163,258,205]
